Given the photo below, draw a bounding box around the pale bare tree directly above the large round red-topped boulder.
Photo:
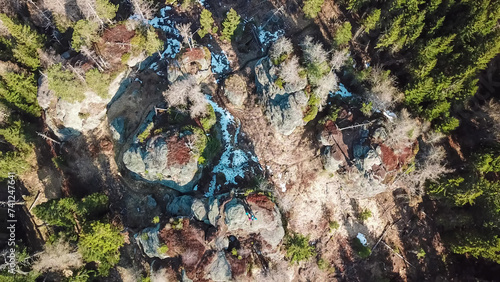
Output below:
[163,76,208,118]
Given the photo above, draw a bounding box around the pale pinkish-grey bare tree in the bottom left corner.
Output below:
[33,239,83,272]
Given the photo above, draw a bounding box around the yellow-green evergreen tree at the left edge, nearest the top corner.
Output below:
[0,14,45,70]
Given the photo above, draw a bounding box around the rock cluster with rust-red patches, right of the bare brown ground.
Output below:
[317,115,418,198]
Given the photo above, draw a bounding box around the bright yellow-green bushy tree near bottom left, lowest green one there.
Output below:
[78,222,124,276]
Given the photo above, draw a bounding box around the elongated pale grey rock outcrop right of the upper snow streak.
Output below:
[255,59,308,135]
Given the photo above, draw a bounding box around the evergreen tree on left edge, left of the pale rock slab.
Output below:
[0,72,41,117]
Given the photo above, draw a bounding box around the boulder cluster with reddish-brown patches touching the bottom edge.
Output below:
[134,194,285,281]
